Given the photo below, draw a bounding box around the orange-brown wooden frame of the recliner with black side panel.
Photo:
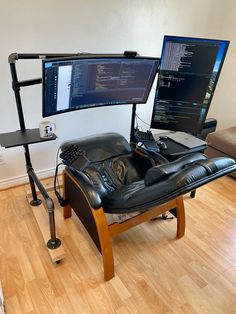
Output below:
[63,169,185,280]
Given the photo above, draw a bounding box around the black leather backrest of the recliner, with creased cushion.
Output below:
[62,133,155,195]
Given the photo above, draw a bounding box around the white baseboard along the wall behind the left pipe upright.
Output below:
[0,168,58,191]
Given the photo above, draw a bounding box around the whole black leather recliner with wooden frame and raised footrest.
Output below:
[61,133,236,280]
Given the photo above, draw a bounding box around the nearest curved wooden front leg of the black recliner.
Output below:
[92,208,115,280]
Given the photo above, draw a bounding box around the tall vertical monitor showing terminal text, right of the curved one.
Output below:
[151,36,229,135]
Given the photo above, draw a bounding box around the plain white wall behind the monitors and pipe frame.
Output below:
[0,0,235,188]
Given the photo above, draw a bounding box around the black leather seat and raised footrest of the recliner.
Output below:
[101,158,235,213]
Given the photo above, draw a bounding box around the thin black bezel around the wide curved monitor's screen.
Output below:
[42,53,161,118]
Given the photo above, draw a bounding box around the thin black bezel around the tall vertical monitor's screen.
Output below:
[150,35,230,135]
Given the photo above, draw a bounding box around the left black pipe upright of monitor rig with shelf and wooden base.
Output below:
[0,53,75,263]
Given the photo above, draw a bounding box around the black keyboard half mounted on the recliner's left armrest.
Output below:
[60,144,89,171]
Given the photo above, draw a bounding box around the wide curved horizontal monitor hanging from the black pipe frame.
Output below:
[42,54,160,117]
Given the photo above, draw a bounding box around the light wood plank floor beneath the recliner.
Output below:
[0,177,236,314]
